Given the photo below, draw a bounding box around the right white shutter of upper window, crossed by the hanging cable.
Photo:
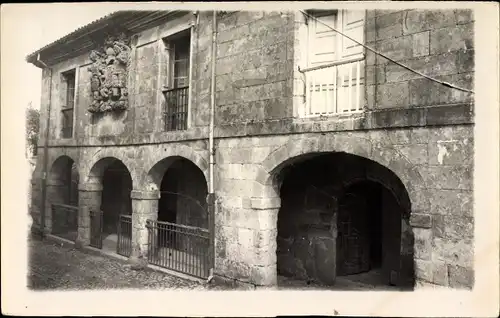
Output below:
[339,10,365,59]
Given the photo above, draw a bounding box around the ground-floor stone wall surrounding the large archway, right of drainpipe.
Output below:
[215,126,473,287]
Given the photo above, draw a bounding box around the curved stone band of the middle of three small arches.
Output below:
[80,148,138,186]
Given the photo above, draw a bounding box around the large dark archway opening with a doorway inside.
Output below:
[276,152,414,289]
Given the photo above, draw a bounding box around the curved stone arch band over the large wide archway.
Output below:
[262,135,428,212]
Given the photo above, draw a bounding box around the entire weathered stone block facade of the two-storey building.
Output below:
[31,10,474,288]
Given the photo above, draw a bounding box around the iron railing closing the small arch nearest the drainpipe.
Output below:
[146,220,210,278]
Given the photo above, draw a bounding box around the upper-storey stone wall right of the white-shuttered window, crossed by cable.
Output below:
[365,9,474,110]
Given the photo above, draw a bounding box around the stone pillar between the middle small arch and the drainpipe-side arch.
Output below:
[130,190,160,268]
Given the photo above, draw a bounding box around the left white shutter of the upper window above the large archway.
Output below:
[308,13,338,66]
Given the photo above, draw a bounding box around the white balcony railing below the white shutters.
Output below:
[300,57,364,118]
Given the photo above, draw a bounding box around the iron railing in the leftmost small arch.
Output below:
[52,203,78,241]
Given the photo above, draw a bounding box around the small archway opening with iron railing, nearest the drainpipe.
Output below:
[149,156,210,277]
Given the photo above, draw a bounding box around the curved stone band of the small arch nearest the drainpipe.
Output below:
[139,144,209,191]
